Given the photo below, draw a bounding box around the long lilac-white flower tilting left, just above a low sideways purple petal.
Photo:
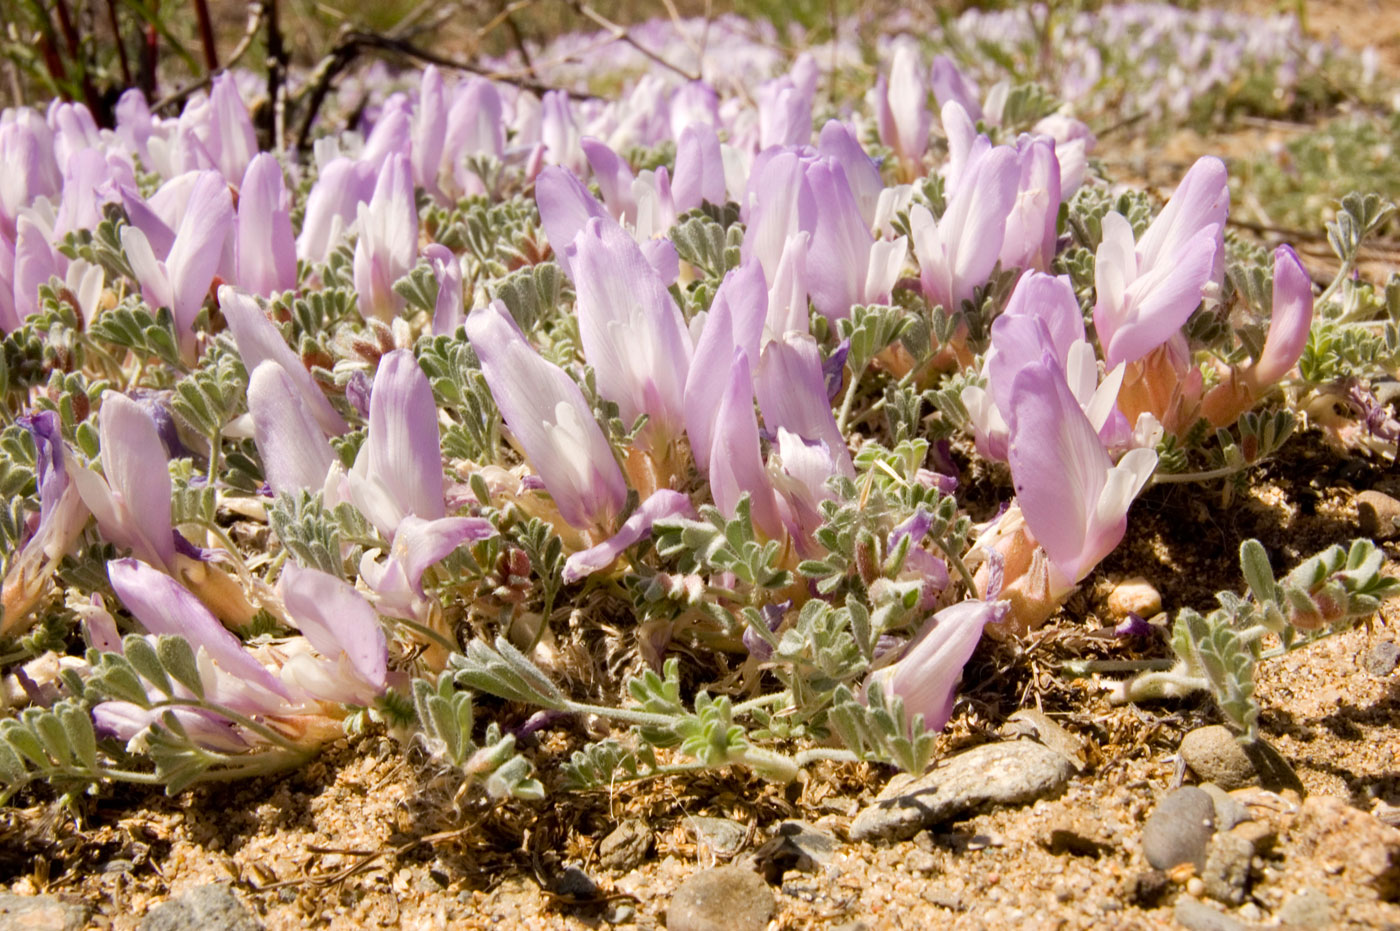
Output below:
[464,301,627,532]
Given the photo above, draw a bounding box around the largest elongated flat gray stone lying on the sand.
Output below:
[851,741,1074,840]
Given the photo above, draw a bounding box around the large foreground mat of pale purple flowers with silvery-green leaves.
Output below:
[0,3,1383,791]
